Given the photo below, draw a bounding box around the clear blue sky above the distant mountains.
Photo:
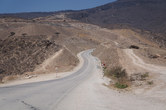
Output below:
[0,0,115,13]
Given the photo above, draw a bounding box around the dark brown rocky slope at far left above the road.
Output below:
[0,36,61,79]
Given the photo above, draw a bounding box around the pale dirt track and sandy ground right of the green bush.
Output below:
[120,49,166,103]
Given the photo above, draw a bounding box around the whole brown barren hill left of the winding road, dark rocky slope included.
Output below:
[0,18,99,82]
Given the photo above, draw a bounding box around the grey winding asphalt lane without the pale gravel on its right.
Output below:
[0,50,96,110]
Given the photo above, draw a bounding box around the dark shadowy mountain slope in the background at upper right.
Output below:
[68,0,166,46]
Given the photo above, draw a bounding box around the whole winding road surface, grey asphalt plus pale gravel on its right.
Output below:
[0,50,166,110]
